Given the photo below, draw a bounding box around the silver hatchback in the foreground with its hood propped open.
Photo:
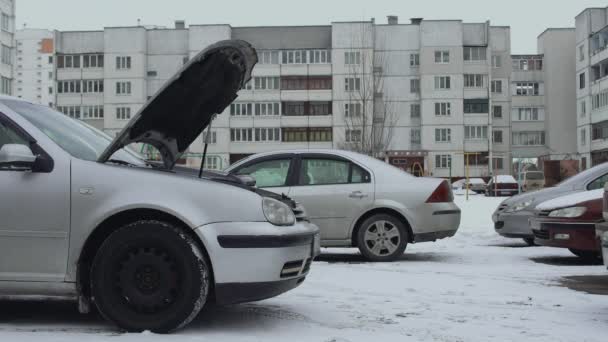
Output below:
[0,41,319,333]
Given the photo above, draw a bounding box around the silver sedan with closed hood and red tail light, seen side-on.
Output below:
[226,150,460,261]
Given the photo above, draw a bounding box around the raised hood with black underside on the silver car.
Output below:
[97,40,257,169]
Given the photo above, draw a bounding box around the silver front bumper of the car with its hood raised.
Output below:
[196,222,320,305]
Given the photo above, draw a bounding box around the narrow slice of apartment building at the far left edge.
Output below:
[0,0,15,95]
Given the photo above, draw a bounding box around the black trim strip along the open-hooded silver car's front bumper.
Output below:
[217,233,315,248]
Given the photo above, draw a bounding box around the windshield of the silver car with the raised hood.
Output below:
[2,100,146,166]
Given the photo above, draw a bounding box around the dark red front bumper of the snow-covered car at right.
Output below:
[530,217,599,252]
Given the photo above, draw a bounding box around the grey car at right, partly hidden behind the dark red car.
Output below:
[492,163,608,245]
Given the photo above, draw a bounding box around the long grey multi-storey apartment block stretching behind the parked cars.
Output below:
[13,16,576,177]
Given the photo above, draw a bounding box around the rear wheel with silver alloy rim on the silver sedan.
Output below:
[357,214,409,261]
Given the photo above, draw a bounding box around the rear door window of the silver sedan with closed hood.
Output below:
[298,158,350,185]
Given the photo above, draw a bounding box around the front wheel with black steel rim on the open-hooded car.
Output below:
[91,221,210,334]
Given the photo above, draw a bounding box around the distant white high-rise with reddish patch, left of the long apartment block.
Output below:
[13,29,55,107]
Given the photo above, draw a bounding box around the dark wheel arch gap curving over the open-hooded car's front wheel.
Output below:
[76,208,214,300]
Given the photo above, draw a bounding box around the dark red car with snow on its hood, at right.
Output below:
[530,189,604,260]
